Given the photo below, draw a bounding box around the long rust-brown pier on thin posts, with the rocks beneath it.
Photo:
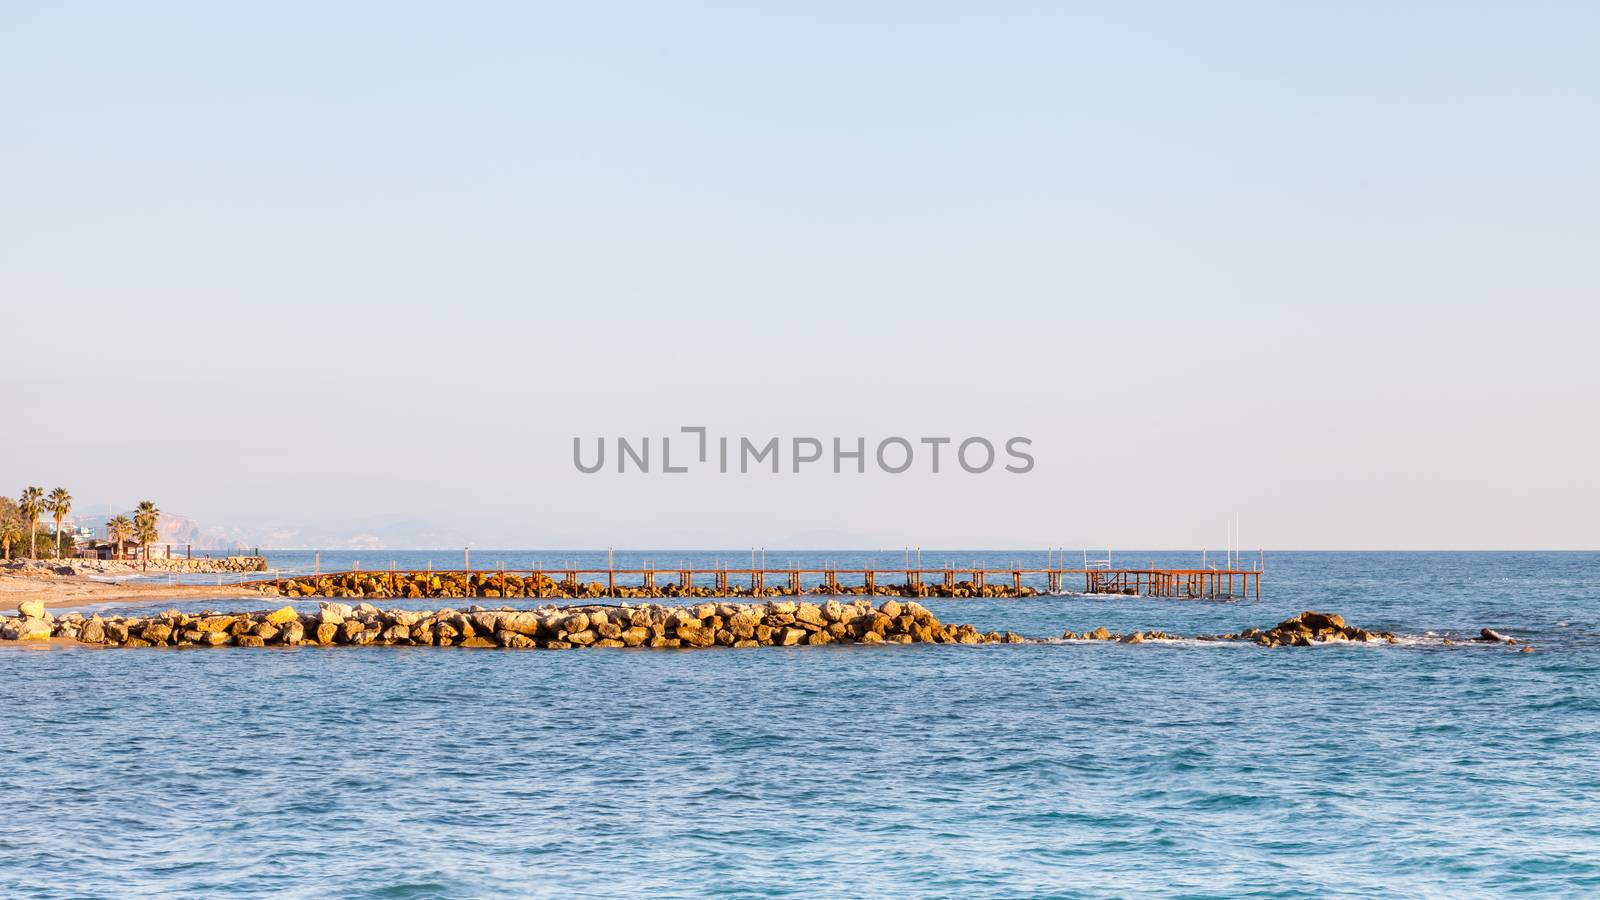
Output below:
[245,562,1264,601]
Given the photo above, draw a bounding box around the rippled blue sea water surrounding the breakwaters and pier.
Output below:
[0,551,1600,897]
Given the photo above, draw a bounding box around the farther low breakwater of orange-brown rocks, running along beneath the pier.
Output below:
[250,572,1038,601]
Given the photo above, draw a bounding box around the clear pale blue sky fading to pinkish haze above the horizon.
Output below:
[0,2,1600,549]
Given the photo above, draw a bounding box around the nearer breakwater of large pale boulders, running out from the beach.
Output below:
[0,599,1026,650]
